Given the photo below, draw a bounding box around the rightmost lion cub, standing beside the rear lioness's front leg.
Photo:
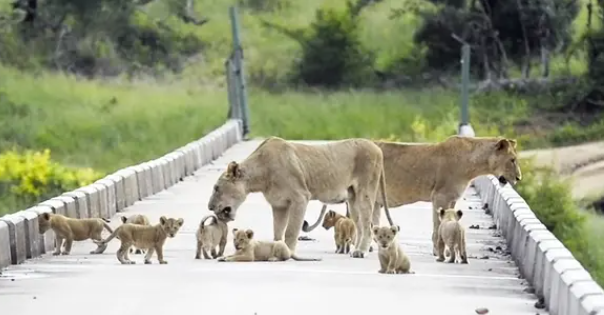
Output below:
[436,208,468,264]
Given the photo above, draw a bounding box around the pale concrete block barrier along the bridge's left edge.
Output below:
[0,119,243,271]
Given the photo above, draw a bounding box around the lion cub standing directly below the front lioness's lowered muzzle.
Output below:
[195,214,229,259]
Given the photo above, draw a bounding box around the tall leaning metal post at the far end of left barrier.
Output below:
[229,6,250,137]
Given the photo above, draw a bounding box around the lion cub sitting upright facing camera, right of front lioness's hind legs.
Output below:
[372,225,414,274]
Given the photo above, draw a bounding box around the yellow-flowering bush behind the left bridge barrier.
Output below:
[0,149,102,213]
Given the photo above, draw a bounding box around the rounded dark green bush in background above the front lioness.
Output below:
[297,2,373,88]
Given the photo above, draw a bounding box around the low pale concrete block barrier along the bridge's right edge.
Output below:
[473,176,604,315]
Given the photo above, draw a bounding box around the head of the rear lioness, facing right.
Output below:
[488,138,522,186]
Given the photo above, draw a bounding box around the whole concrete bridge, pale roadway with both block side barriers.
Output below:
[0,120,604,315]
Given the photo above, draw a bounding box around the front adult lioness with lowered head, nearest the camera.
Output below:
[208,137,392,258]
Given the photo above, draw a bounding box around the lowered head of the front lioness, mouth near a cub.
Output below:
[208,161,247,222]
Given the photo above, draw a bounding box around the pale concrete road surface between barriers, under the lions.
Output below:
[0,141,547,315]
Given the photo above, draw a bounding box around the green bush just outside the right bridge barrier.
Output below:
[515,160,604,285]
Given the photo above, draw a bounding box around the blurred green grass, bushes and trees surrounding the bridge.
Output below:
[0,0,604,283]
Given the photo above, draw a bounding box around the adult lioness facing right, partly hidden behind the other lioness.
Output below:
[305,136,522,255]
